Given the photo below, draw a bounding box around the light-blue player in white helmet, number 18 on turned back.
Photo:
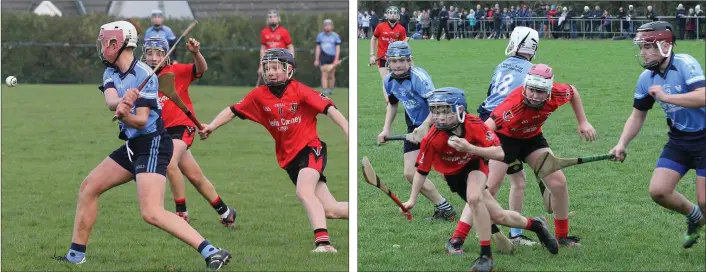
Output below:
[478,26,549,246]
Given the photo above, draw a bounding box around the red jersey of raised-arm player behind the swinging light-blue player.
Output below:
[159,63,201,128]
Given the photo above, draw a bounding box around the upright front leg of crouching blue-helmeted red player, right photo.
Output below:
[466,170,495,271]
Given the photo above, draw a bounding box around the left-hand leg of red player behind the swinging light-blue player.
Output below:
[167,139,191,222]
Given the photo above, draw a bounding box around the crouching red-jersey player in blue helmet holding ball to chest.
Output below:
[404,87,559,271]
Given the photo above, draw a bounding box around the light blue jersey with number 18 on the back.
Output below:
[478,57,532,114]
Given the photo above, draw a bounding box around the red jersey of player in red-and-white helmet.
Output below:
[490,83,574,139]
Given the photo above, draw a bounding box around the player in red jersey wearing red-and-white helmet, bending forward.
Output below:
[485,64,596,246]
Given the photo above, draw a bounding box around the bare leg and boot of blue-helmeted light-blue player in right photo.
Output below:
[404,149,456,221]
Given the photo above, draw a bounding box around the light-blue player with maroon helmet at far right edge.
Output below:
[610,21,706,248]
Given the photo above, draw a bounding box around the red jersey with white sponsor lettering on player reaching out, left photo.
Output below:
[230,80,334,168]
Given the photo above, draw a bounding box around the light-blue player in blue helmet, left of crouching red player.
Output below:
[378,41,456,221]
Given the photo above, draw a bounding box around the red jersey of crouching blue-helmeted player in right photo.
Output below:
[417,114,500,175]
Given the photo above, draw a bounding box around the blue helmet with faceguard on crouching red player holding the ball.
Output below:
[427,87,468,130]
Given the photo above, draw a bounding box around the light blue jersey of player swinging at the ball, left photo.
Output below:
[102,59,164,140]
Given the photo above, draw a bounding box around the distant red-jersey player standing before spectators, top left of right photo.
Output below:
[370,6,409,101]
